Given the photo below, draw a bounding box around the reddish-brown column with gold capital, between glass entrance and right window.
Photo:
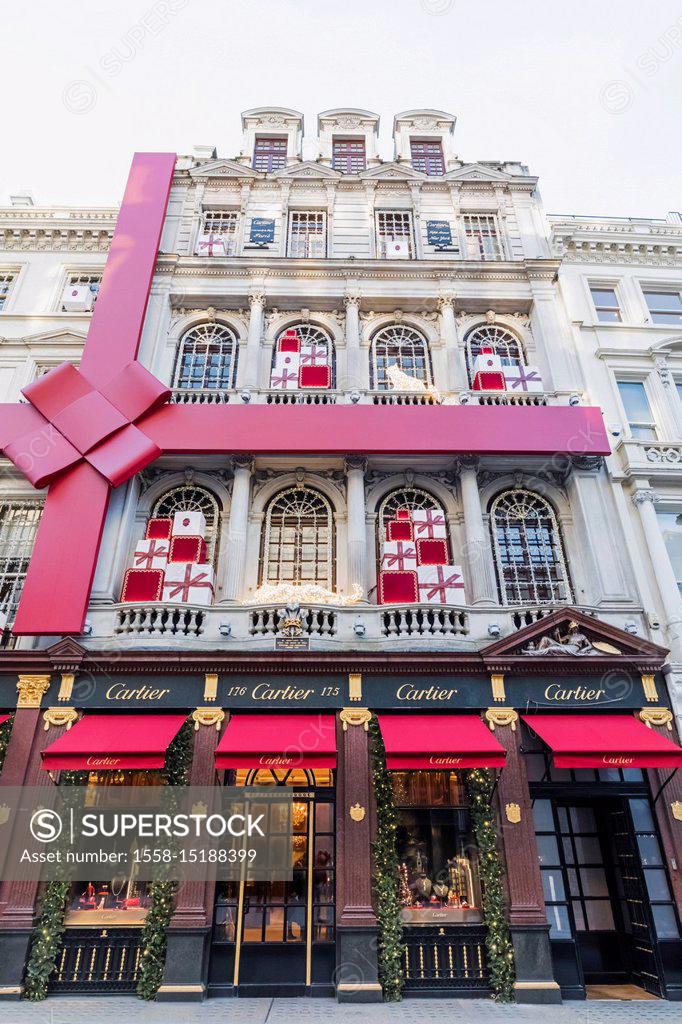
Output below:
[336,708,381,1002]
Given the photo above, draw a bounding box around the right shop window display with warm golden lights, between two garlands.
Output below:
[391,771,482,925]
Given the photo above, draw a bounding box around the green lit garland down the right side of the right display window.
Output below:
[464,768,515,1002]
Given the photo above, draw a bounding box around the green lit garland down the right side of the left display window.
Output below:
[137,721,193,999]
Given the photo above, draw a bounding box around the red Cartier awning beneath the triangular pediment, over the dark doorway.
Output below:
[521,715,682,768]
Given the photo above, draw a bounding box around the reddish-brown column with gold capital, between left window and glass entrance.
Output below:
[157,708,225,1002]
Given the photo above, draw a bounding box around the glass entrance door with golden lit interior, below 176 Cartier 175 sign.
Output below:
[209,769,336,995]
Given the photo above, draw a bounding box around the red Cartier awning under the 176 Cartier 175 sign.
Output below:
[215,715,336,768]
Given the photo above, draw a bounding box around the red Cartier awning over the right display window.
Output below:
[379,715,507,771]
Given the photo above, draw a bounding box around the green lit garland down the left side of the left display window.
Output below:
[24,771,83,1002]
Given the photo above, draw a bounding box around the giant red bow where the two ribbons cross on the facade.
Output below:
[5,361,170,487]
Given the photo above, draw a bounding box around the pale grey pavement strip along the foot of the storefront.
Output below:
[0,995,682,1024]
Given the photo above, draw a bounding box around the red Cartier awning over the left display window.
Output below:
[42,715,186,771]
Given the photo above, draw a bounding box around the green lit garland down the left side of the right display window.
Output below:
[369,716,404,1002]
